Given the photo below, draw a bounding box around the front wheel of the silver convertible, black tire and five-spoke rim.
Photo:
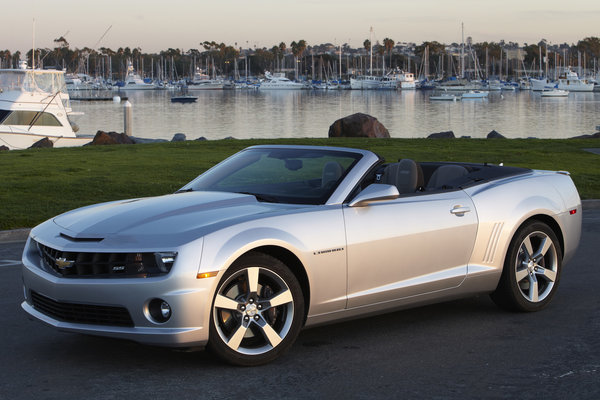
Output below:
[208,252,304,366]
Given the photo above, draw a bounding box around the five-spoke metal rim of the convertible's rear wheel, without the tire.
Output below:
[515,232,558,303]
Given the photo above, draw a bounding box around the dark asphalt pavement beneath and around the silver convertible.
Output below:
[0,209,600,400]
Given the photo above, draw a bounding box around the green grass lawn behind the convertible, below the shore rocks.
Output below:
[0,138,600,230]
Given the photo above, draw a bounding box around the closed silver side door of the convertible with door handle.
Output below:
[344,190,477,308]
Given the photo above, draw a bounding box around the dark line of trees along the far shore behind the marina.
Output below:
[0,36,600,80]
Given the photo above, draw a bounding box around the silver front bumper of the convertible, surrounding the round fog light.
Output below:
[21,238,220,347]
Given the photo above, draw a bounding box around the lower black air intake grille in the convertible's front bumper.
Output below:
[31,291,133,327]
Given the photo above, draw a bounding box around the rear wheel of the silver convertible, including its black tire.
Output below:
[491,221,562,312]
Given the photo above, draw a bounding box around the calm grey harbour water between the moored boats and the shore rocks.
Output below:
[72,90,600,140]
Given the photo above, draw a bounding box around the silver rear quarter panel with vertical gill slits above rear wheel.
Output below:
[465,171,581,290]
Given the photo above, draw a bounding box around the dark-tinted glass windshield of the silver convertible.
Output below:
[182,148,362,204]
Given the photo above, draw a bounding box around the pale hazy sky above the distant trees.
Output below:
[0,0,600,53]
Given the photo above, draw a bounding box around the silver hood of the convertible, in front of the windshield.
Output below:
[48,192,305,245]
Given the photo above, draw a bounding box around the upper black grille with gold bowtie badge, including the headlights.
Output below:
[37,243,175,278]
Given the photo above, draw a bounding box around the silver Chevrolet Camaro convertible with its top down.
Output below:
[22,146,581,365]
